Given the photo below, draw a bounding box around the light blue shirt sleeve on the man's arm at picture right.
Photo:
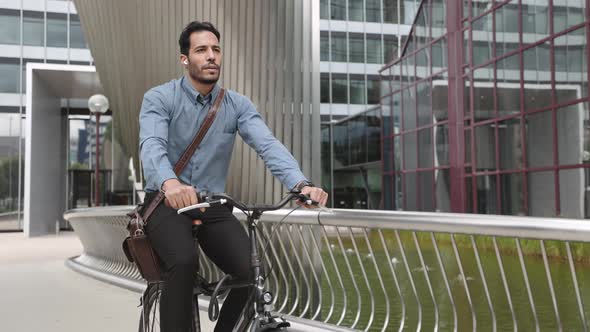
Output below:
[238,97,307,189]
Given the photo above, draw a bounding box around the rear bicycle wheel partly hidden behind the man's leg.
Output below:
[138,284,201,332]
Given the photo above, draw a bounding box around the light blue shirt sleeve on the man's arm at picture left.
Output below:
[139,89,177,188]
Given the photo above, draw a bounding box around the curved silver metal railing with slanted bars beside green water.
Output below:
[65,207,590,331]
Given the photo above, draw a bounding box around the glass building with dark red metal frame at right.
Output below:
[381,0,590,218]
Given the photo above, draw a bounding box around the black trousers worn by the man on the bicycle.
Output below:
[144,193,250,332]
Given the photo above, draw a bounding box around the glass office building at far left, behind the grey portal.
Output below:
[0,0,99,230]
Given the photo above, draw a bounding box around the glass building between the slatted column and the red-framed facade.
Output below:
[320,0,419,209]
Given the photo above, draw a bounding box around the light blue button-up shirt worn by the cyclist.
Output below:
[139,76,306,192]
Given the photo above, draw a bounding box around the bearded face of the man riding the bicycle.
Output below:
[186,31,221,84]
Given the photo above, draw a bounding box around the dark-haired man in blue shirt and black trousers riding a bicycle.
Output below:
[139,21,328,332]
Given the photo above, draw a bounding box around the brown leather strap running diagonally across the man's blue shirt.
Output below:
[143,88,225,223]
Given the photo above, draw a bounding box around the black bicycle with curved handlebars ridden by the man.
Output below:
[139,191,318,332]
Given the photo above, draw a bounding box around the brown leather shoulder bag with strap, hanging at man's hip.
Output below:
[123,89,225,282]
